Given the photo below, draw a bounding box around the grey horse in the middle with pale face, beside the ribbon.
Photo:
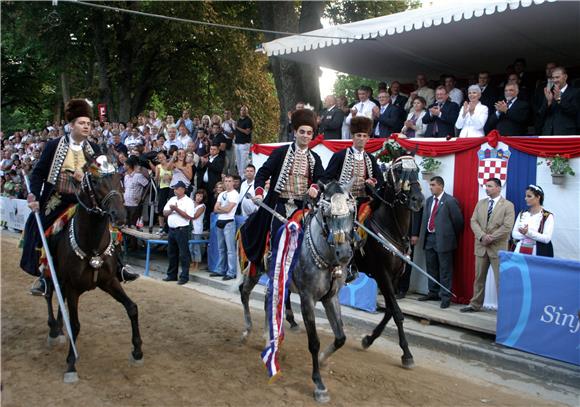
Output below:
[240,181,356,402]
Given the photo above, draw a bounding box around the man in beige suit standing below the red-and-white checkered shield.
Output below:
[461,177,515,312]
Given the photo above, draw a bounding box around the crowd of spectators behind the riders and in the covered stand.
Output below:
[0,59,580,288]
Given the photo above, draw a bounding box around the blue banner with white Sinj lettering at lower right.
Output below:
[496,251,580,365]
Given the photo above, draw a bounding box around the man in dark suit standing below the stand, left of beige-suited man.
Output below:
[411,176,463,308]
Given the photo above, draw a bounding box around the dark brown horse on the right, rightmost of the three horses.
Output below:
[354,156,424,369]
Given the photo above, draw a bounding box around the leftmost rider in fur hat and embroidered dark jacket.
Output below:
[20,99,138,295]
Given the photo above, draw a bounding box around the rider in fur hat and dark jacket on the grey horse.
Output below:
[241,109,324,263]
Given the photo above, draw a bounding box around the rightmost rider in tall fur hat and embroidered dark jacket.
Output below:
[323,116,385,204]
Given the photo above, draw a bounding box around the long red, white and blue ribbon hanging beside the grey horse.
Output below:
[262,222,303,381]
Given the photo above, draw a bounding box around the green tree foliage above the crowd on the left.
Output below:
[1,1,279,139]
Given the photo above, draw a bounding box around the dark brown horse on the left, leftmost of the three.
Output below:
[45,159,143,383]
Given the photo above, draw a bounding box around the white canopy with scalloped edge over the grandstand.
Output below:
[262,0,580,82]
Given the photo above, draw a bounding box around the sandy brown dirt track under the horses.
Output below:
[1,235,554,407]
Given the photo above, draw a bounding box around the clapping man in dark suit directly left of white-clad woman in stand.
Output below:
[423,86,459,137]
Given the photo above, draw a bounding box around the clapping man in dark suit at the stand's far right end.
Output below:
[539,67,580,136]
